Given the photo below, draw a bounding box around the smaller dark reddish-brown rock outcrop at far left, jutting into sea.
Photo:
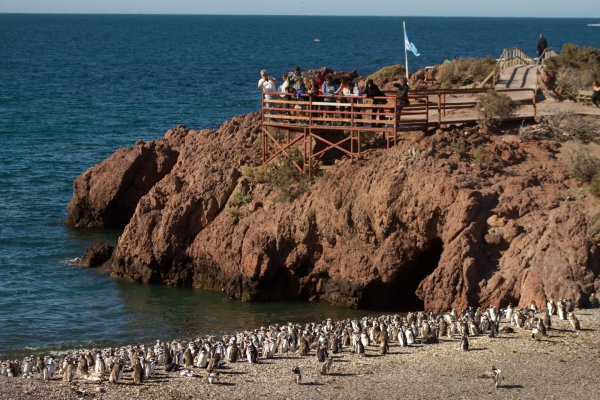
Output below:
[66,126,187,228]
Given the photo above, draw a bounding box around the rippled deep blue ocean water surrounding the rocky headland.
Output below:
[0,14,600,356]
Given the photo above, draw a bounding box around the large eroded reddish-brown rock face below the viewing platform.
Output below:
[74,113,600,311]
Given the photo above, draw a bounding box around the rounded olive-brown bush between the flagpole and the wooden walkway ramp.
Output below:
[436,57,496,88]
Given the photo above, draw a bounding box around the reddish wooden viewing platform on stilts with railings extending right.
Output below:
[262,88,537,174]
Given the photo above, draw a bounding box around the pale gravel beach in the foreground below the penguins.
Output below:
[0,309,600,400]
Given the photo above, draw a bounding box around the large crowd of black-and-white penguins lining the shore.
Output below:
[0,300,597,387]
